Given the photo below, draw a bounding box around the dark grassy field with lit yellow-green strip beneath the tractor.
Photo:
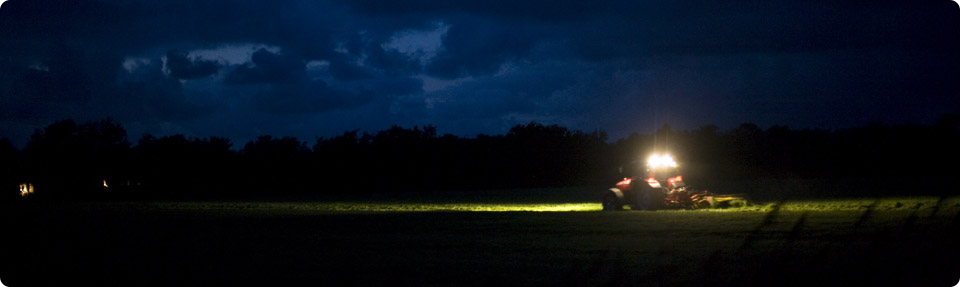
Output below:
[0,189,960,286]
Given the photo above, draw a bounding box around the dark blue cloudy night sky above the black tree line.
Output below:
[0,0,960,146]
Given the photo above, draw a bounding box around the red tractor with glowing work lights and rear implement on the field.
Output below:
[602,154,745,211]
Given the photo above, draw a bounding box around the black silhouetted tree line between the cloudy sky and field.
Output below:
[0,114,960,200]
